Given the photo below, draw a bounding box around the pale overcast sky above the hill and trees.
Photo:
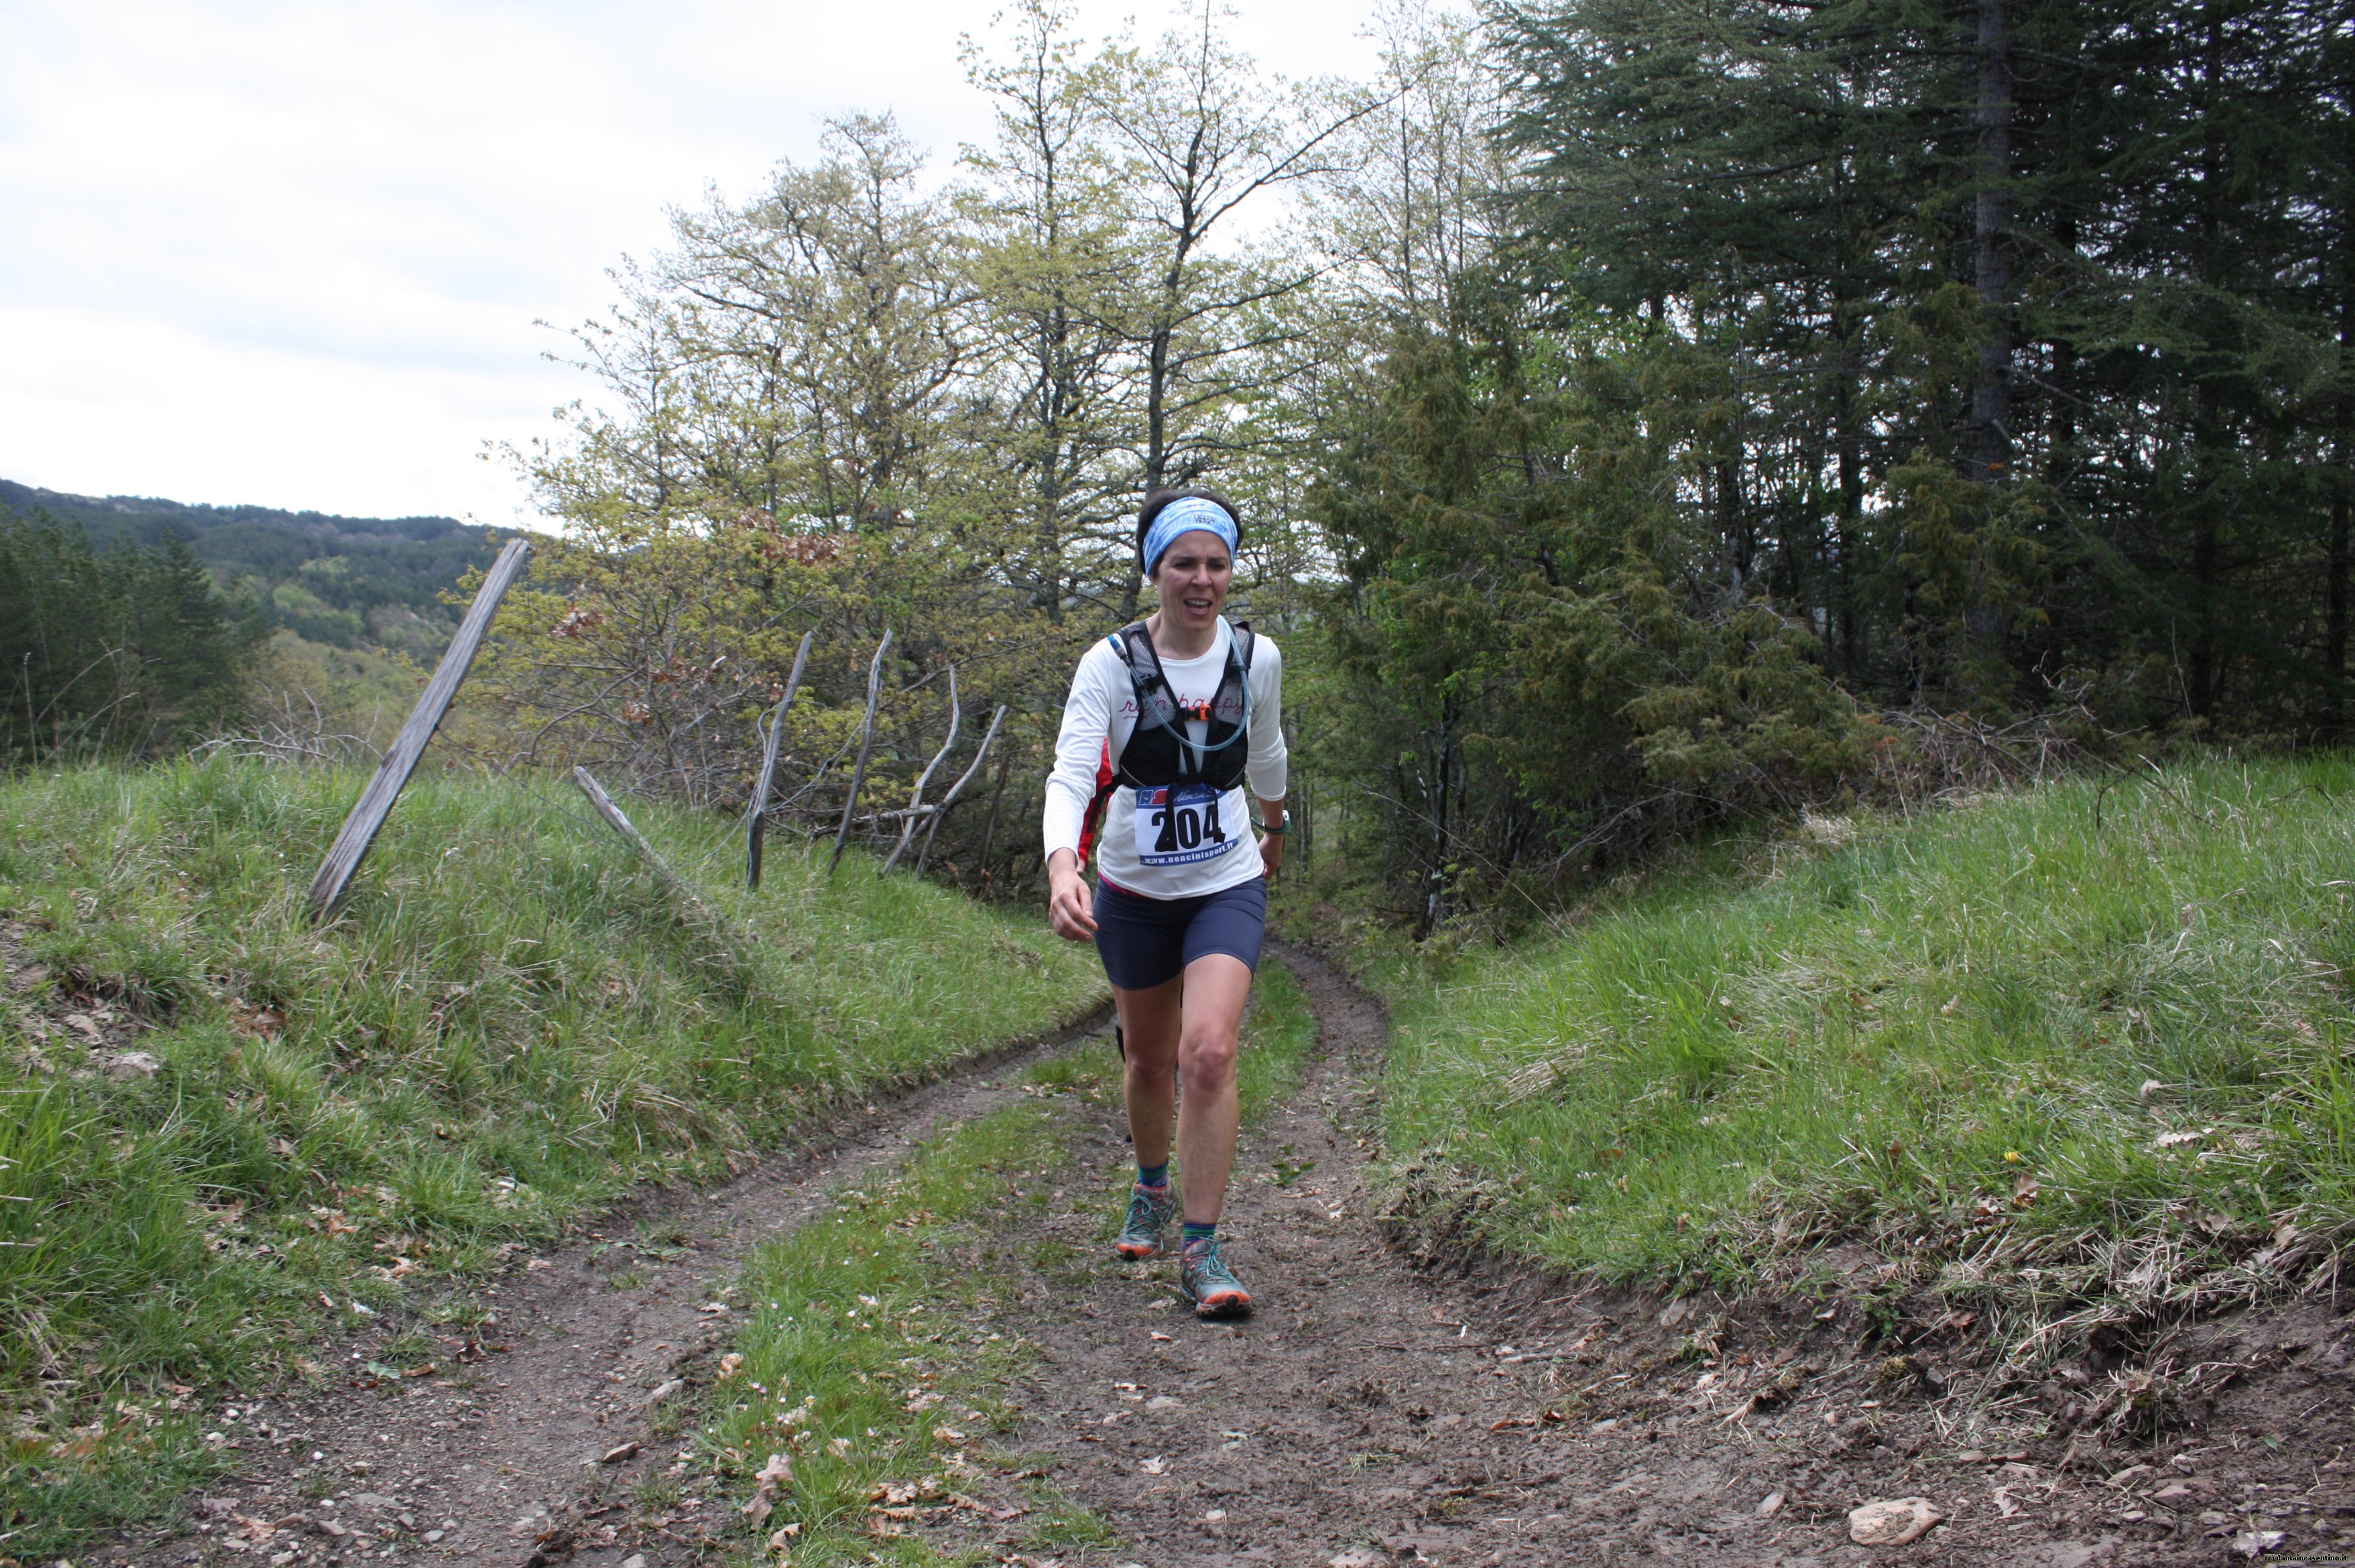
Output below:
[0,0,1373,525]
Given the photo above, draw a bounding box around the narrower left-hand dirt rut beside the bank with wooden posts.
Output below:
[124,1007,1112,1568]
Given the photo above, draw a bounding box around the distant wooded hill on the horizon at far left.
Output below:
[0,480,497,657]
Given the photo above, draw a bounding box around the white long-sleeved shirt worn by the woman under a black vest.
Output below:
[1046,622,1286,899]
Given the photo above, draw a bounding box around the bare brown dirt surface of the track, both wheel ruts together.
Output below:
[124,944,2355,1568]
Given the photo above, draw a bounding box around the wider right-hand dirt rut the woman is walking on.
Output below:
[1013,949,2355,1568]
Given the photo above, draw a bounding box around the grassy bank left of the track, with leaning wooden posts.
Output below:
[0,760,1102,1554]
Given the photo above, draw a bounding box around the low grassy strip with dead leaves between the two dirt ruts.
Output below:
[692,946,1316,1568]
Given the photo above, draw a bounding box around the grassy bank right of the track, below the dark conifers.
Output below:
[1380,756,2355,1314]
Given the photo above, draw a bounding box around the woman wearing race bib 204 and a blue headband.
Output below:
[1046,490,1290,1319]
